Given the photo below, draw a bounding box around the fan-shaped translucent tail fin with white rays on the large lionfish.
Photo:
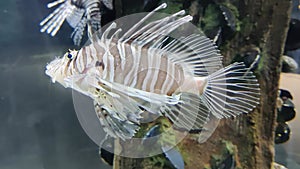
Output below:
[201,63,260,118]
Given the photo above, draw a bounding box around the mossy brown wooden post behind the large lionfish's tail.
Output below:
[114,0,291,169]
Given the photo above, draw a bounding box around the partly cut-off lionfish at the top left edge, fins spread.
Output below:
[40,0,113,46]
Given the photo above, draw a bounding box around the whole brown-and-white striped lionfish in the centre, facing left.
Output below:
[46,3,260,140]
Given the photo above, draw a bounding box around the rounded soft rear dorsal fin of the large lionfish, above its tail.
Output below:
[163,34,222,77]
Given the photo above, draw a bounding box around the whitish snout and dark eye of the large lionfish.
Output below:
[45,50,78,87]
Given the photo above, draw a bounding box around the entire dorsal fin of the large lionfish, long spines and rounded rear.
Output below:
[97,5,222,76]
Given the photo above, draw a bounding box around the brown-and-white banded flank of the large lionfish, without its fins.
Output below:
[74,38,190,95]
